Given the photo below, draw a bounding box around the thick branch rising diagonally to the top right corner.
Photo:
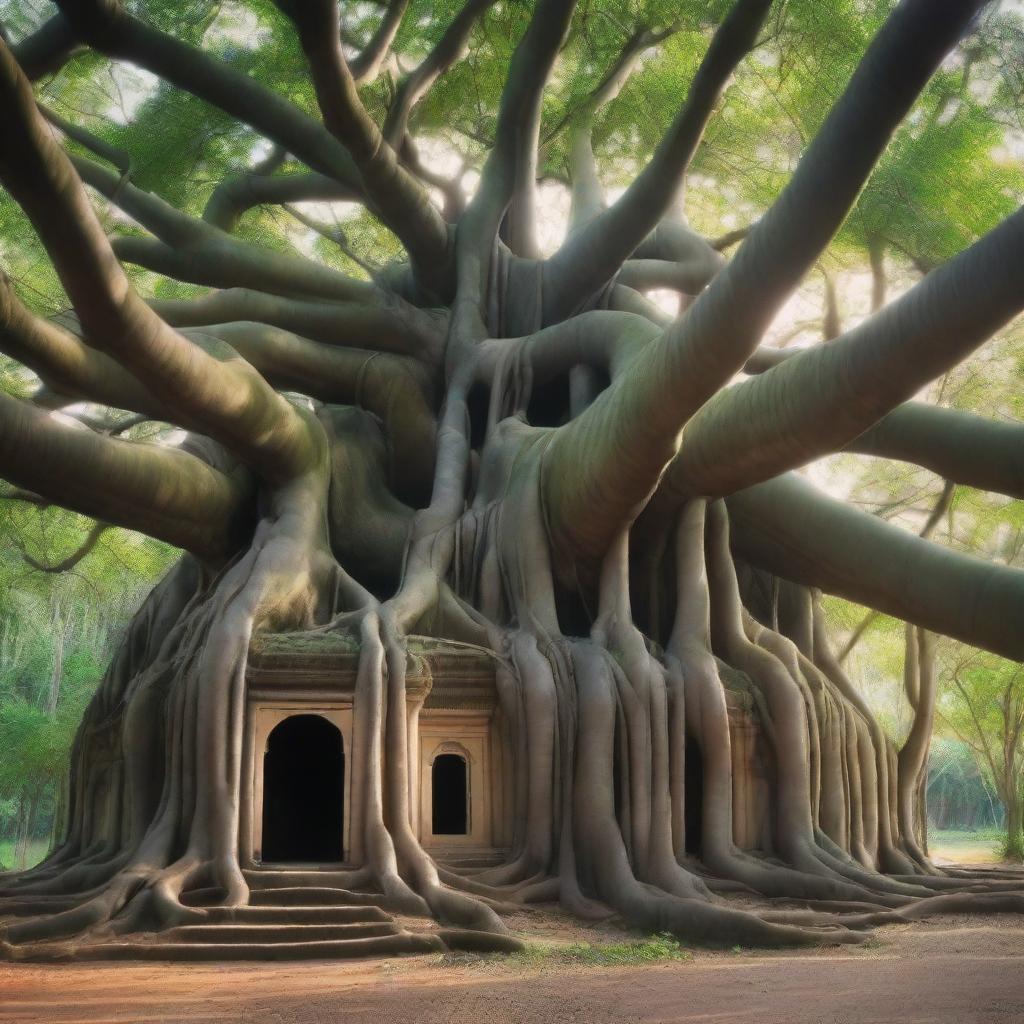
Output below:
[545,0,983,579]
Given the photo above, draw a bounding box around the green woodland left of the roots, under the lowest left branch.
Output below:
[0,500,174,866]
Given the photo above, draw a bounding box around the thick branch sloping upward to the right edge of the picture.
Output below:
[663,202,1024,496]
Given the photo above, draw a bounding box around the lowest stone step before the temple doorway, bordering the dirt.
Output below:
[72,932,445,961]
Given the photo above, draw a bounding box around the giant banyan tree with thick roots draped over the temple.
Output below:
[0,0,1024,956]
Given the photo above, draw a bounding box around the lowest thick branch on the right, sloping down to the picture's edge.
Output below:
[727,474,1024,660]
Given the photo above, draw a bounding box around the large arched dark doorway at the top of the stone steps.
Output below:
[262,715,345,863]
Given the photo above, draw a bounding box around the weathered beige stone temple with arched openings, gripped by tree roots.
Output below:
[241,634,771,868]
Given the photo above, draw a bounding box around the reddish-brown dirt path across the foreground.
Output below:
[0,915,1024,1024]
